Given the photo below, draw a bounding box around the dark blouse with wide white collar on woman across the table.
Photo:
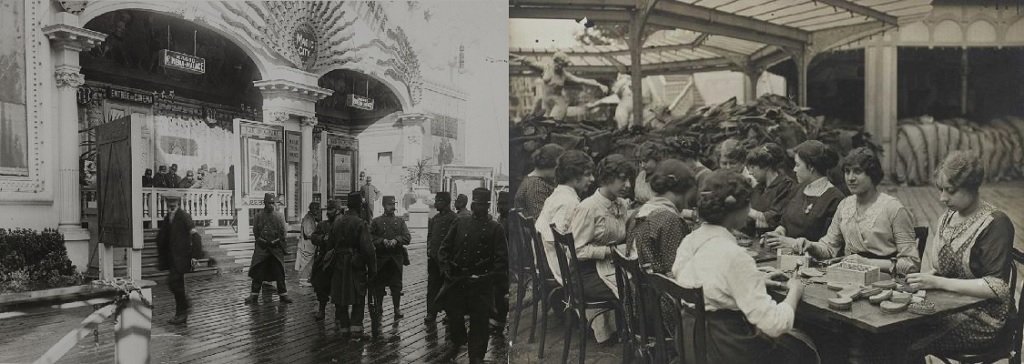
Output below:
[781,177,845,241]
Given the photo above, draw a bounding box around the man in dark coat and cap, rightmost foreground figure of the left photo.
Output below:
[437,188,508,363]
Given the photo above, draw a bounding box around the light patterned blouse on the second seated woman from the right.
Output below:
[807,194,921,273]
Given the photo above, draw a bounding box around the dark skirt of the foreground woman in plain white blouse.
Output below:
[682,311,817,364]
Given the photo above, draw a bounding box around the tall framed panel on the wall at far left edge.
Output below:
[0,0,30,177]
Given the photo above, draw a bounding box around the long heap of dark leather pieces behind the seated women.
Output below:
[509,94,882,191]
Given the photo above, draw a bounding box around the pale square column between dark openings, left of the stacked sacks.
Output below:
[864,45,898,179]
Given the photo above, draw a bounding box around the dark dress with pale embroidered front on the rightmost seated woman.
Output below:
[913,203,1014,354]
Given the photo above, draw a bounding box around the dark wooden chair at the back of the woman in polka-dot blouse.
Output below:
[611,250,658,363]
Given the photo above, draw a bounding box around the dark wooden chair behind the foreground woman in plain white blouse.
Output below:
[648,274,708,364]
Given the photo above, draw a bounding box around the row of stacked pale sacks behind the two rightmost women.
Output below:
[893,116,1024,186]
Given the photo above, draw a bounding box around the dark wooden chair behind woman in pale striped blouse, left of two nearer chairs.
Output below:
[550,224,622,364]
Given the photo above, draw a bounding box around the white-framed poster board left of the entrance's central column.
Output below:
[234,119,285,208]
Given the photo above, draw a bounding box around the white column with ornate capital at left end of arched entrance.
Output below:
[43,20,106,271]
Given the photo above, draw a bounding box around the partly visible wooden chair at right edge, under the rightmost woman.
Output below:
[939,248,1024,364]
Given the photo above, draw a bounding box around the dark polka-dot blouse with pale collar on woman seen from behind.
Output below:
[626,197,690,274]
